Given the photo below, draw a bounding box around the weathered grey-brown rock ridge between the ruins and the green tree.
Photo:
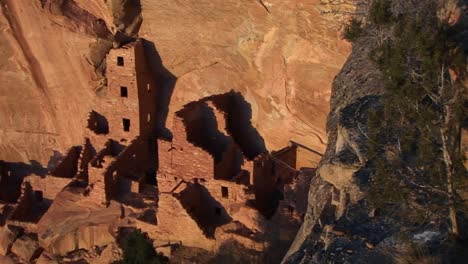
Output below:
[285,32,384,263]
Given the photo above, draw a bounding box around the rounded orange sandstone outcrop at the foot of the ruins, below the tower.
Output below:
[38,183,121,255]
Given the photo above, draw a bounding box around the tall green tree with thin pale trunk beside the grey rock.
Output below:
[352,0,466,236]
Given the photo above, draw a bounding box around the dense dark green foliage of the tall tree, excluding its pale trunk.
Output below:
[367,0,466,218]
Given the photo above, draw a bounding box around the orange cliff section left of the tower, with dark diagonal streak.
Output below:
[0,0,104,164]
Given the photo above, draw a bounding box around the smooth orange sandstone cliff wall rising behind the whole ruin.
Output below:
[0,0,353,164]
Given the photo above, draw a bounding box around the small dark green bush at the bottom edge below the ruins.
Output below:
[114,230,169,264]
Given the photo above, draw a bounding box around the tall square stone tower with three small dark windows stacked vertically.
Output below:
[101,39,157,143]
